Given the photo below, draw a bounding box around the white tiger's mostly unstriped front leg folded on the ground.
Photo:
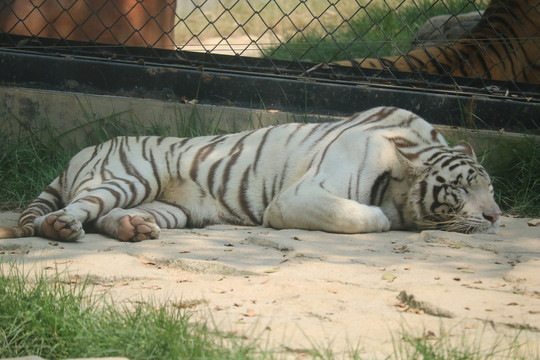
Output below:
[263,182,390,234]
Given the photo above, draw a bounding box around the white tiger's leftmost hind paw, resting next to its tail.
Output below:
[39,212,84,241]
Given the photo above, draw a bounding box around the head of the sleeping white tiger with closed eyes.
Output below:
[408,143,501,233]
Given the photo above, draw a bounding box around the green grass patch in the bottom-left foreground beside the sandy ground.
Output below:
[0,264,255,360]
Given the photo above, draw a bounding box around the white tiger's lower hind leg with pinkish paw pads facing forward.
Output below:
[96,201,188,241]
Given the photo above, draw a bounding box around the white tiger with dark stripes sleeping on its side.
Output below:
[0,107,501,241]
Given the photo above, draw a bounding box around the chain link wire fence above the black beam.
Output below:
[0,0,540,100]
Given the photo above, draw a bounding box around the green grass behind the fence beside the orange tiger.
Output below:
[265,0,488,63]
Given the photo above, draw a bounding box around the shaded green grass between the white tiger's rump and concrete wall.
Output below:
[0,103,225,210]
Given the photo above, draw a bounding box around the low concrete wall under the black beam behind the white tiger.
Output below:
[0,87,523,163]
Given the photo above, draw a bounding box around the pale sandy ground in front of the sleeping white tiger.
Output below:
[0,213,540,359]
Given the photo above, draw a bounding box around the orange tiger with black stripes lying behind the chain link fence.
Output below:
[333,0,540,83]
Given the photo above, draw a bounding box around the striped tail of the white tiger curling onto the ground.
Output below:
[0,178,63,239]
